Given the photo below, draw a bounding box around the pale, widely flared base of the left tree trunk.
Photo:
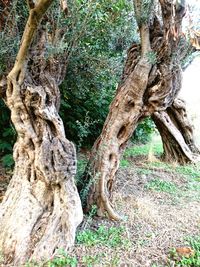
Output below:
[0,159,82,266]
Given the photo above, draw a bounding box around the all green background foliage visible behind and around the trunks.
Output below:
[0,0,155,155]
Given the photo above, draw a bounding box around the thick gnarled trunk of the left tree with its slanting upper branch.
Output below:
[0,0,82,266]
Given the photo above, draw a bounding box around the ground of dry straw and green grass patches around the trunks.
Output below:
[0,137,200,267]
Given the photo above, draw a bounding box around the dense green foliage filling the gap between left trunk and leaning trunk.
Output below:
[60,0,138,147]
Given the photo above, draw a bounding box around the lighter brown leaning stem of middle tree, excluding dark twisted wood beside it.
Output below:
[79,2,152,220]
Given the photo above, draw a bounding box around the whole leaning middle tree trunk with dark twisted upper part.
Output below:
[79,0,197,219]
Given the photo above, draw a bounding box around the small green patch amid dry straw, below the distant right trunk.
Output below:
[146,179,177,194]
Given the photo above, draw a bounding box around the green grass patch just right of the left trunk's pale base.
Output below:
[76,226,130,248]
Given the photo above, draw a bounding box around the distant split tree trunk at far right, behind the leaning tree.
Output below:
[152,99,199,164]
